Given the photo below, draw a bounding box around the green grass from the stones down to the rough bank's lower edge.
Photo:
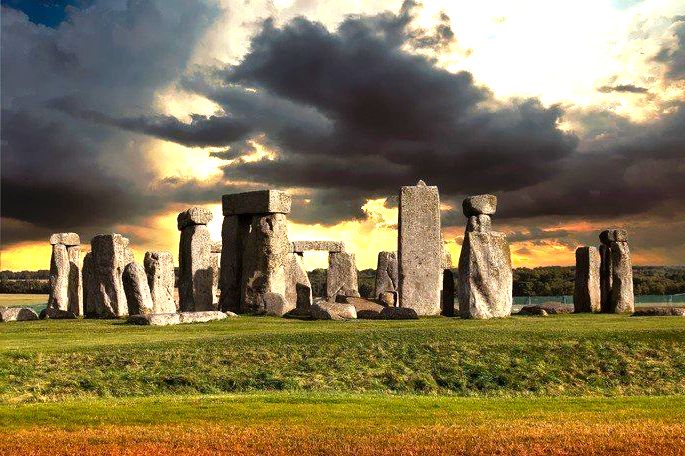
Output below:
[0,315,685,403]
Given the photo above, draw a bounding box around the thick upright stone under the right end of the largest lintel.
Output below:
[239,214,295,314]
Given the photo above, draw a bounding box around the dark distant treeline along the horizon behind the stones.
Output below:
[0,266,685,297]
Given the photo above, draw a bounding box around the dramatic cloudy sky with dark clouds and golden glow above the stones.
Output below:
[0,0,685,270]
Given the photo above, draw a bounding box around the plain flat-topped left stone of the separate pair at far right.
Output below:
[573,247,602,312]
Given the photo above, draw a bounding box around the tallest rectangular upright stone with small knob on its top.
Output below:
[398,181,443,315]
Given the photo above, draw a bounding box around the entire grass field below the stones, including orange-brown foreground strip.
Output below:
[0,315,685,455]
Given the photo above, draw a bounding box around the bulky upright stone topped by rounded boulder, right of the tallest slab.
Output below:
[458,195,513,319]
